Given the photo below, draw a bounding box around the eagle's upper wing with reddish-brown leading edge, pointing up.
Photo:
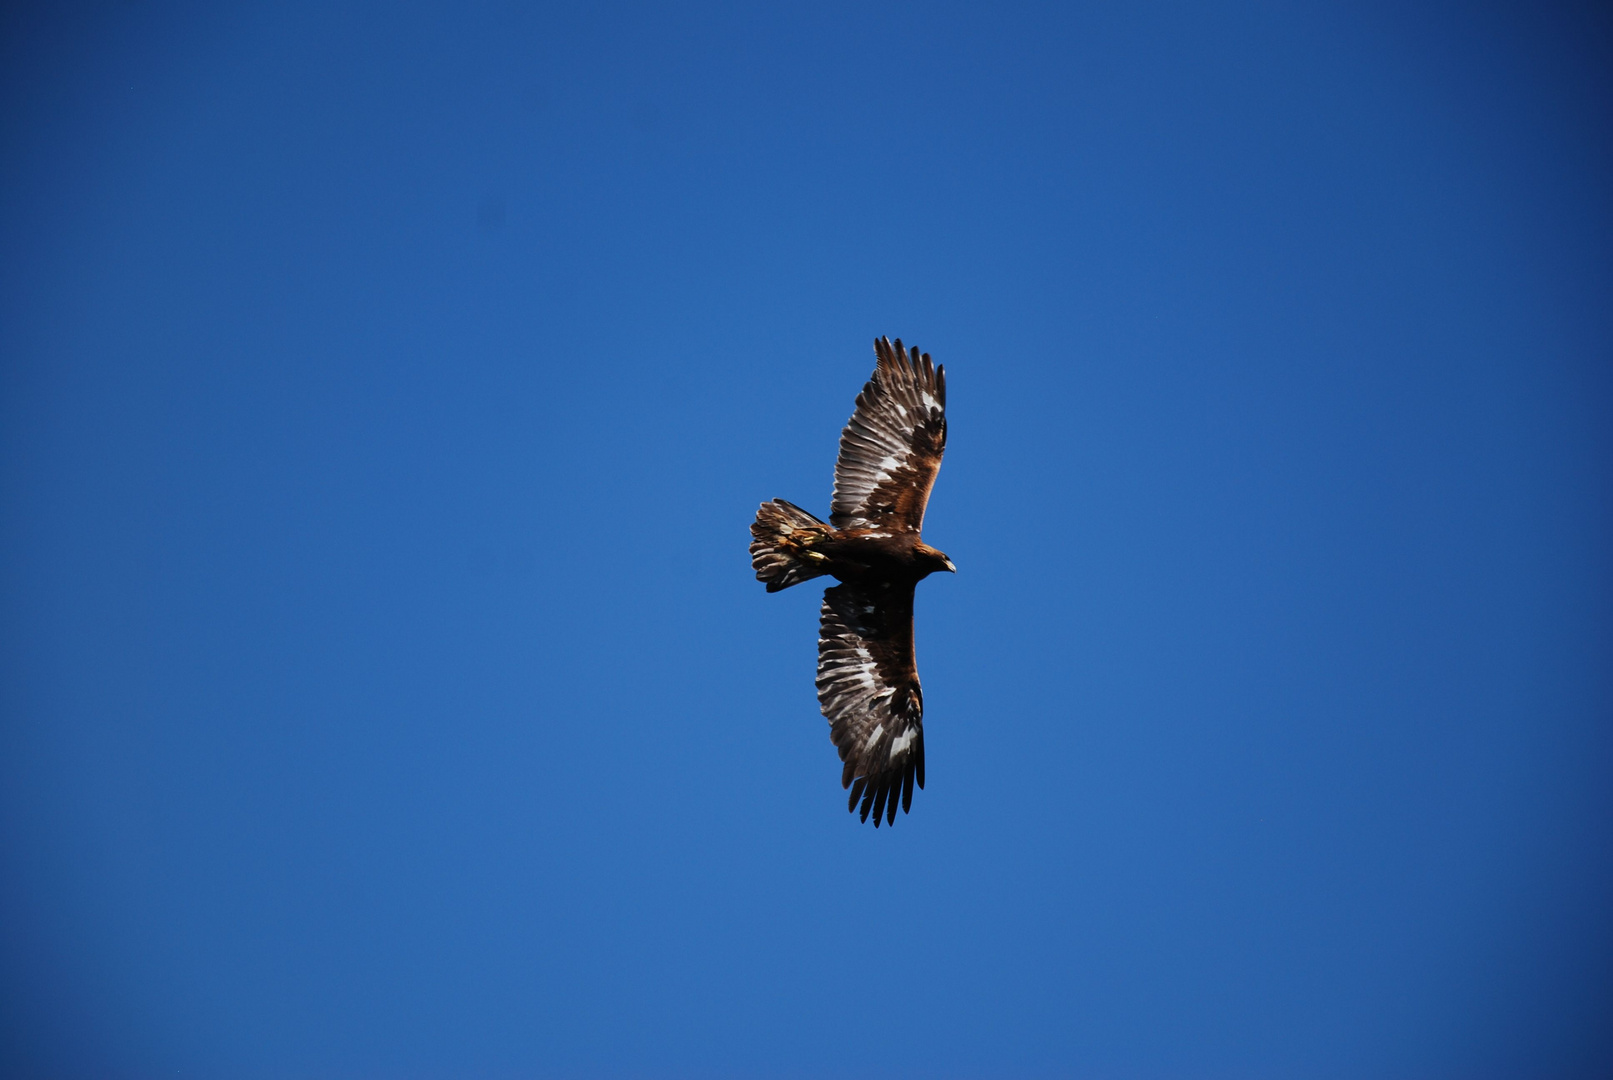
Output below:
[829,339,947,532]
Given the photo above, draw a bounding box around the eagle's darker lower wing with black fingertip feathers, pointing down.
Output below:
[818,584,924,829]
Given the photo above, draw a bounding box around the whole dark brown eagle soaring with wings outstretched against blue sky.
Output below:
[750,339,957,829]
